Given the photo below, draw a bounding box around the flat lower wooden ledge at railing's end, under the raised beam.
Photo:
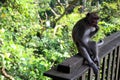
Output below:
[44,65,89,80]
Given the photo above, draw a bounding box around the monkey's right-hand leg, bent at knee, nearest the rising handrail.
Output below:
[88,41,100,67]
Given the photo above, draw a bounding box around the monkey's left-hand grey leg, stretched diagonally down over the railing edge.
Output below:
[78,46,99,74]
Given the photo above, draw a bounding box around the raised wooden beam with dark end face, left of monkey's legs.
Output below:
[57,54,83,73]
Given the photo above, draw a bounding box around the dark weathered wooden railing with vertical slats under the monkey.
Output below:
[44,31,120,80]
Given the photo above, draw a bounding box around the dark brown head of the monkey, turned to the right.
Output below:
[86,12,99,27]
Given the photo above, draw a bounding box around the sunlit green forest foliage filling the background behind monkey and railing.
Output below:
[0,0,120,80]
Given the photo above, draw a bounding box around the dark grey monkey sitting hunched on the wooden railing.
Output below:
[72,12,102,74]
